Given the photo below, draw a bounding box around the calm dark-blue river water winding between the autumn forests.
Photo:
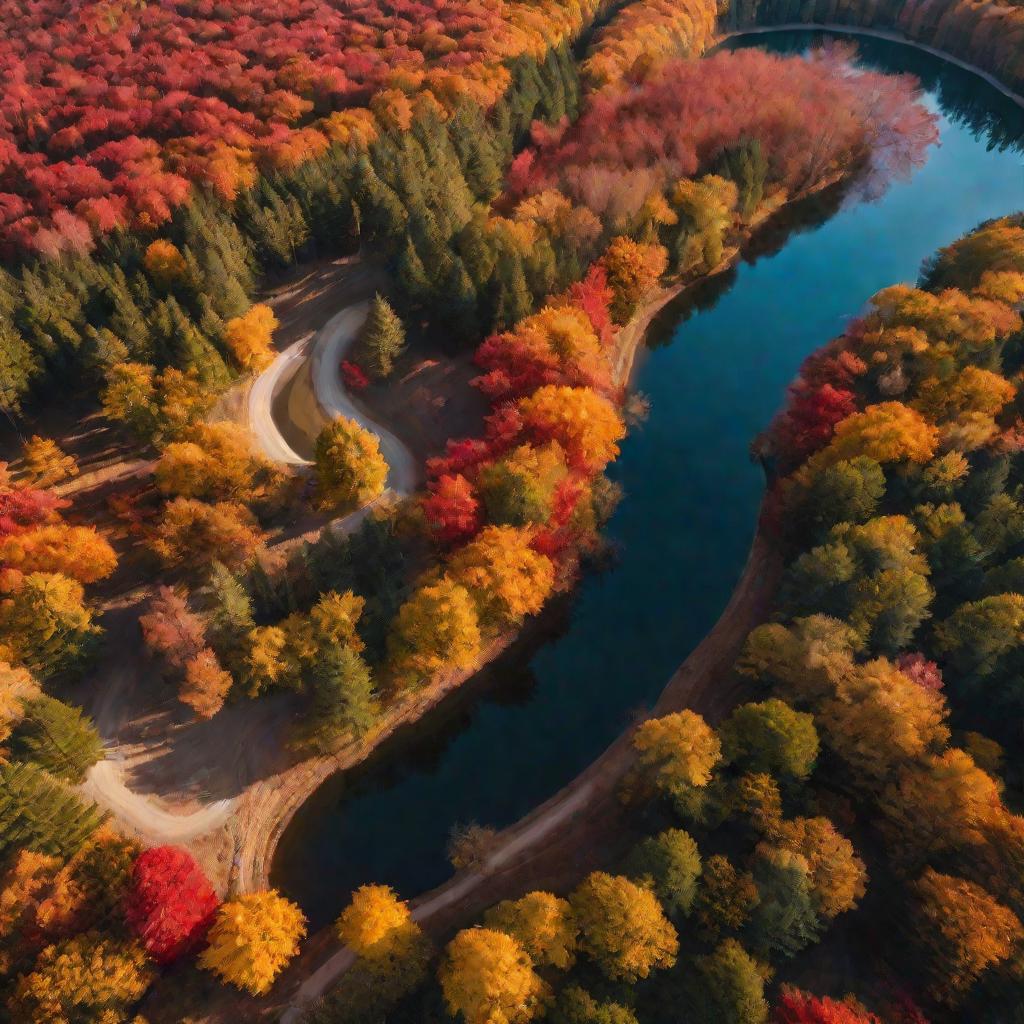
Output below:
[273,33,1024,926]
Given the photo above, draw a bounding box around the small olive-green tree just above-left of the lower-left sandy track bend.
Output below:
[10,695,103,782]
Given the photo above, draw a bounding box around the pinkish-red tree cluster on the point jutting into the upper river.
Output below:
[509,47,936,241]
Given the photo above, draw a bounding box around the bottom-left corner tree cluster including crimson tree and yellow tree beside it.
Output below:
[0,753,303,1024]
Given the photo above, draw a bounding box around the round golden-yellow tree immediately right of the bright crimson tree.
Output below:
[200,889,306,995]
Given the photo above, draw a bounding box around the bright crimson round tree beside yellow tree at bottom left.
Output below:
[124,846,219,964]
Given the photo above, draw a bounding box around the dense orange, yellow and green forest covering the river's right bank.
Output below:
[309,217,1024,1024]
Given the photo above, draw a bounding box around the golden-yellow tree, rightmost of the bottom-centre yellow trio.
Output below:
[569,871,679,982]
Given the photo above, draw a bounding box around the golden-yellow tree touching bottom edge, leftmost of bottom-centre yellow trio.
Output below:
[439,928,549,1024]
